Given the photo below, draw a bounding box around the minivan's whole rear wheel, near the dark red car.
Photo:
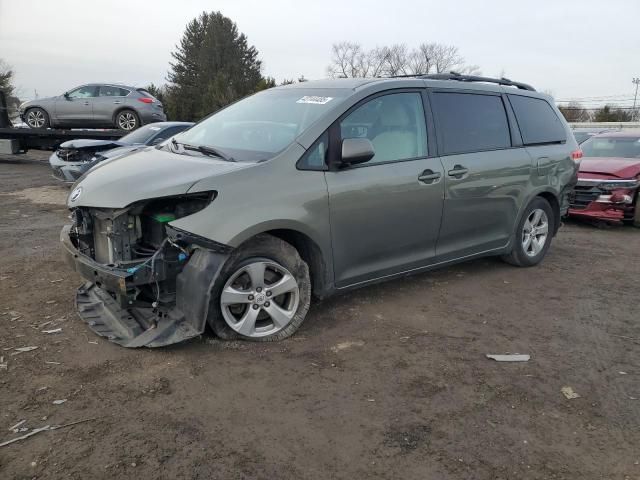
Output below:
[502,197,555,267]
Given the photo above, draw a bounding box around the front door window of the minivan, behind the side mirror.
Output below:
[340,92,427,164]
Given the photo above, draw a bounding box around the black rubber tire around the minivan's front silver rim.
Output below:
[207,234,311,342]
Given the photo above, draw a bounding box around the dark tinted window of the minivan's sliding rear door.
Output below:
[433,92,511,155]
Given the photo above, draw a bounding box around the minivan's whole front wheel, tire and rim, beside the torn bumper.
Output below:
[208,235,311,342]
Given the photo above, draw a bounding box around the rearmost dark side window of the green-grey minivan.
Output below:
[509,95,567,145]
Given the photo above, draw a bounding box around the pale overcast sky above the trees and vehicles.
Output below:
[0,0,640,103]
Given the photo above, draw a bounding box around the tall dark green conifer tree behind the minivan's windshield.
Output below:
[165,12,272,121]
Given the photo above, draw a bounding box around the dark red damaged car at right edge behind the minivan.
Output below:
[569,130,640,226]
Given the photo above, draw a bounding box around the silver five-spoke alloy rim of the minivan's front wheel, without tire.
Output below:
[220,261,300,338]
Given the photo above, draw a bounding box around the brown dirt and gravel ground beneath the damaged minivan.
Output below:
[0,152,640,480]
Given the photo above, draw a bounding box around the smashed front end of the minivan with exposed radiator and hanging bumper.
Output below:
[61,192,230,347]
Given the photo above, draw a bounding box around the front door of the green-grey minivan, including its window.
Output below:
[325,90,444,288]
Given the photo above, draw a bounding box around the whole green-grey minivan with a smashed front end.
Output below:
[61,74,581,347]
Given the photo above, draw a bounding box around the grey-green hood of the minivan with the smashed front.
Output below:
[67,147,255,208]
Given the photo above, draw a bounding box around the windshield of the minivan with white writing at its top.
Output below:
[176,88,346,162]
